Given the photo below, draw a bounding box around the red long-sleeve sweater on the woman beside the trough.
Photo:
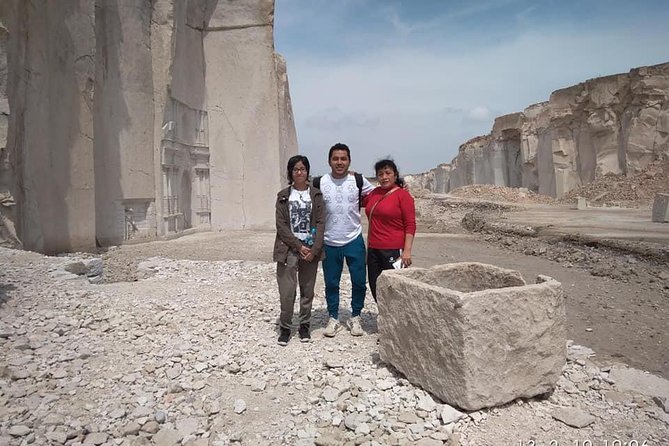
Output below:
[364,187,416,249]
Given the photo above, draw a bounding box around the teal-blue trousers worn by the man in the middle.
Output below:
[323,234,367,319]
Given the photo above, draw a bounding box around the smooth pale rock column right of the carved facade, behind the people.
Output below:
[204,0,284,229]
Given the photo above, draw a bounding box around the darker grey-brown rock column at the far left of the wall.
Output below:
[2,0,95,253]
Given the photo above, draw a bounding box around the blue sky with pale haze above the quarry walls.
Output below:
[274,0,669,175]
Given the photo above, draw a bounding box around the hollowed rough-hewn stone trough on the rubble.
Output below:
[377,263,567,410]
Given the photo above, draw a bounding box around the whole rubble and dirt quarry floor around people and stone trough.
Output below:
[0,199,669,446]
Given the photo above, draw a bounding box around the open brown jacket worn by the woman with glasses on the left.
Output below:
[273,186,325,263]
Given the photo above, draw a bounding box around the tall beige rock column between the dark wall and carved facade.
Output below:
[95,0,156,245]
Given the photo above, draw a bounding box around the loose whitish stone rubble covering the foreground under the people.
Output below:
[0,248,669,446]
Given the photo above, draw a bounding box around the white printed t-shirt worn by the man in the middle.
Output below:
[320,174,374,246]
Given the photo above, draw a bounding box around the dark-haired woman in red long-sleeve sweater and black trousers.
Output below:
[365,159,416,301]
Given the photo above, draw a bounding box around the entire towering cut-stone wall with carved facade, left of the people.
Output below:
[0,0,297,253]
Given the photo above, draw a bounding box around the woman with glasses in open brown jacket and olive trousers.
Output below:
[274,155,325,345]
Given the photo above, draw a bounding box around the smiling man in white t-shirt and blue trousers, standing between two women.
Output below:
[319,143,374,337]
